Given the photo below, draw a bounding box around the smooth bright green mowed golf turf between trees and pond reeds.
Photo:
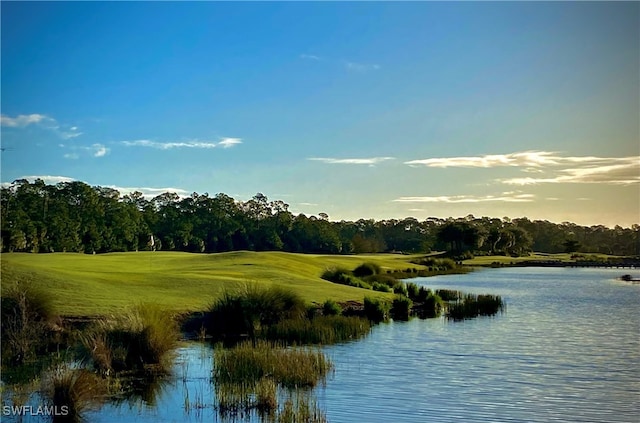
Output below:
[1,251,422,316]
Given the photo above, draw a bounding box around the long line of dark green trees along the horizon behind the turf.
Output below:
[0,179,640,256]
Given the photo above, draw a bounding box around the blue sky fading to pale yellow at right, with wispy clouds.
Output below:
[0,1,640,227]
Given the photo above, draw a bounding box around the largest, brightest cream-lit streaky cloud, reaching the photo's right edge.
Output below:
[405,151,640,185]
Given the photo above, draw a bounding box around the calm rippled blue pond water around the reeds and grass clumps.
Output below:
[3,268,640,423]
